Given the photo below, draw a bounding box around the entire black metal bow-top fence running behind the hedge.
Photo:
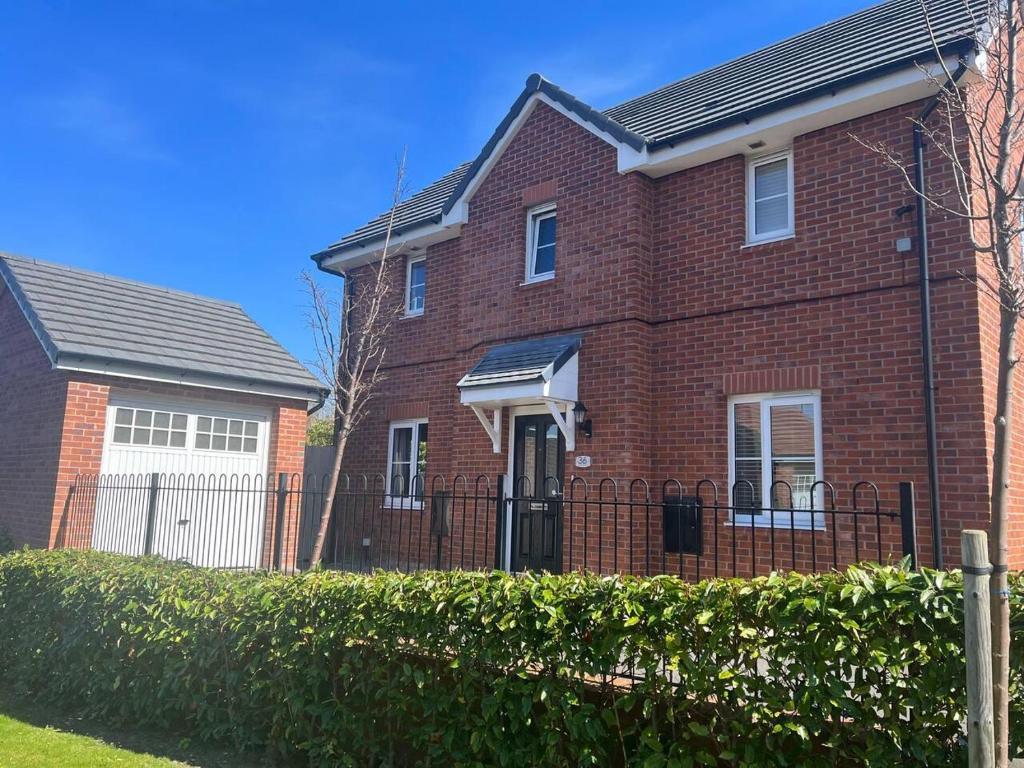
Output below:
[57,474,916,579]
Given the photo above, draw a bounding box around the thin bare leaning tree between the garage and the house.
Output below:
[302,152,406,563]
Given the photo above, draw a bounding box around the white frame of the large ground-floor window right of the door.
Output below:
[728,390,825,530]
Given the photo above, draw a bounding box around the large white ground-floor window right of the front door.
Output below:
[729,392,824,527]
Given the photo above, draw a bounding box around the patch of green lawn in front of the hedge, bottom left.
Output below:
[0,693,267,768]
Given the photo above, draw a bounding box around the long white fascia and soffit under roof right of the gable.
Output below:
[618,57,974,178]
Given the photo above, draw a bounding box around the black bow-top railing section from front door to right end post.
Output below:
[506,478,916,580]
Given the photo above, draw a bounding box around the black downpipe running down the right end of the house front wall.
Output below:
[913,59,967,569]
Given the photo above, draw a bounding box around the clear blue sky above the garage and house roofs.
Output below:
[0,0,870,372]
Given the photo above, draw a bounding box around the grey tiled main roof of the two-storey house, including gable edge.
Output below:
[313,0,987,262]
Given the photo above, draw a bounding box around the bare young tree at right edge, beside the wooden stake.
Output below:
[858,0,1024,768]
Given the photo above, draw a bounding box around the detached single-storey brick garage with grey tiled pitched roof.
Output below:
[0,253,323,559]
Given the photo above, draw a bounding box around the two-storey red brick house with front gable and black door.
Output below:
[313,0,1024,567]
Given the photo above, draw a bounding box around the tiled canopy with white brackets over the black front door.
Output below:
[459,335,582,454]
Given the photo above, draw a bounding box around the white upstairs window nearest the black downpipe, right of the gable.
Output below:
[746,151,795,243]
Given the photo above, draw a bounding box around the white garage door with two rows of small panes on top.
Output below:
[93,395,269,568]
